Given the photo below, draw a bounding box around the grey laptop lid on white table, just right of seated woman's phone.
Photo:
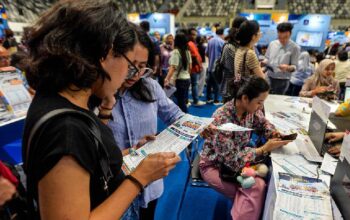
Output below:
[308,111,327,156]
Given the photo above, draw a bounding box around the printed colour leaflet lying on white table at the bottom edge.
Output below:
[273,173,333,220]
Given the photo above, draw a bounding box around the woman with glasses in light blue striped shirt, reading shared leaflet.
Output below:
[108,25,184,219]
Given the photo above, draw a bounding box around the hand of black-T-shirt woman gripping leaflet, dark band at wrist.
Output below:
[132,152,180,186]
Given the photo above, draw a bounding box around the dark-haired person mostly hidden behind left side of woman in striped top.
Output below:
[220,16,247,103]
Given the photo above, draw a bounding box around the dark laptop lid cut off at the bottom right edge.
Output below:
[330,158,350,220]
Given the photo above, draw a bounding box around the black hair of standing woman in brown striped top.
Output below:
[236,20,260,46]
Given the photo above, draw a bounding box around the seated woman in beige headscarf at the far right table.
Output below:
[299,59,340,97]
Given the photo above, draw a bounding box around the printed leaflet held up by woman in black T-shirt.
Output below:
[122,114,214,174]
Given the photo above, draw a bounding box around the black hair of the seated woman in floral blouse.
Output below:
[236,76,270,101]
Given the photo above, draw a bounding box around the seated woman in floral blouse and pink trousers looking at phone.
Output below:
[199,76,289,219]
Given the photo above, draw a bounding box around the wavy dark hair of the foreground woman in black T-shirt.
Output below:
[26,0,137,92]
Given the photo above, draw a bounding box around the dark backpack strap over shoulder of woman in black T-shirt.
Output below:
[21,108,113,219]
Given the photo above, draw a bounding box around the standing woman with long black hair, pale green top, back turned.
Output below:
[164,32,192,113]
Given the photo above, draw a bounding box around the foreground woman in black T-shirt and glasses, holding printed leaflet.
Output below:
[23,0,179,220]
